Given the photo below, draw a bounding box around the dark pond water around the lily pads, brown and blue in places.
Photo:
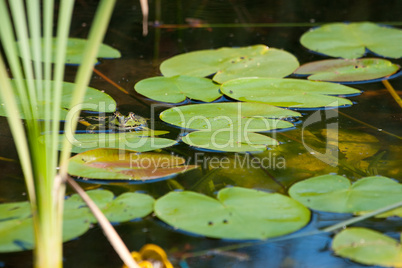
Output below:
[0,0,402,268]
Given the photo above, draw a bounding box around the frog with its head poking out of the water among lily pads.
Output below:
[109,111,148,131]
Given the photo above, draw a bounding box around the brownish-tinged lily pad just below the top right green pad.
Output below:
[295,58,400,82]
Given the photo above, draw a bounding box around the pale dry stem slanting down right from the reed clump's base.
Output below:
[67,176,140,268]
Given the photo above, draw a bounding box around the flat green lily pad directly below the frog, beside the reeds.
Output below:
[53,130,177,153]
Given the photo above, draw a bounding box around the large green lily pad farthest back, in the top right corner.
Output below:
[300,22,402,59]
